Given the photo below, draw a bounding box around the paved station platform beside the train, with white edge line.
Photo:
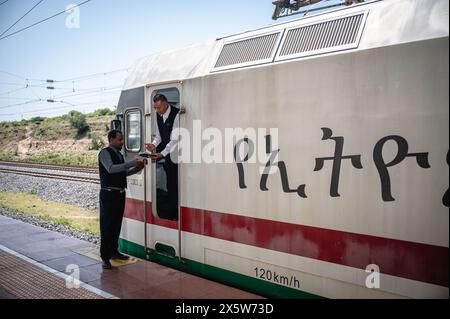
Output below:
[0,216,263,299]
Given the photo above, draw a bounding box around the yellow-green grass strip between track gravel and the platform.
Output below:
[0,191,100,235]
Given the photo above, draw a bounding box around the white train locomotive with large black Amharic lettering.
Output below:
[113,0,449,298]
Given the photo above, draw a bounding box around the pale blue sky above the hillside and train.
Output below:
[0,0,341,121]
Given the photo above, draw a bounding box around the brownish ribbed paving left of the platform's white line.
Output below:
[0,251,103,299]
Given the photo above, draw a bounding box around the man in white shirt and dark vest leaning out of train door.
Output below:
[146,94,179,220]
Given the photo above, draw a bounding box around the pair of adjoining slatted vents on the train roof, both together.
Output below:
[211,10,369,72]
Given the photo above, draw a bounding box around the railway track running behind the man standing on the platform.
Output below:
[0,161,100,184]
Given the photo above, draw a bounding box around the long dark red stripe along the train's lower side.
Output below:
[125,198,449,287]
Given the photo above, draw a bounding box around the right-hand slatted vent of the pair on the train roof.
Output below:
[275,12,368,61]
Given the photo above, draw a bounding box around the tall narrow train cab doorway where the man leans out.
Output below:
[145,82,182,260]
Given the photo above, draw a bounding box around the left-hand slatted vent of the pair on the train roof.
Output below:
[212,31,281,72]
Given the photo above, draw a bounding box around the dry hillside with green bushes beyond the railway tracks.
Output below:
[0,109,114,166]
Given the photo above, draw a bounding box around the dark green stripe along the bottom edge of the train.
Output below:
[119,239,322,299]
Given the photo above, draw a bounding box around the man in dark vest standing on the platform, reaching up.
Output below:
[98,130,145,269]
